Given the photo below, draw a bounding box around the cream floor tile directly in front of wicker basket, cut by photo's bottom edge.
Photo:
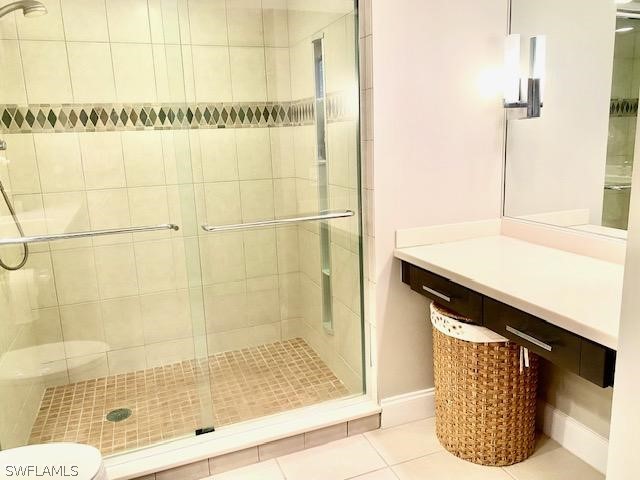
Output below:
[392,452,513,480]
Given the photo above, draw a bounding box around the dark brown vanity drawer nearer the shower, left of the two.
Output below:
[402,263,482,323]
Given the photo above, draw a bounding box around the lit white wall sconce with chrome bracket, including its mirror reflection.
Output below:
[504,34,546,118]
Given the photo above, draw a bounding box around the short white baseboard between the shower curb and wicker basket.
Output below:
[380,388,436,428]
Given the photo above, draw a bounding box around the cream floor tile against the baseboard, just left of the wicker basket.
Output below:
[365,418,443,465]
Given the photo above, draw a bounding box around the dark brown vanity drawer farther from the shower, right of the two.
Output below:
[484,298,582,374]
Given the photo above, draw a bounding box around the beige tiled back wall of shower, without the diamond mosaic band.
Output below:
[0,0,300,394]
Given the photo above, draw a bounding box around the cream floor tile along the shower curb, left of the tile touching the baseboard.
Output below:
[278,435,386,480]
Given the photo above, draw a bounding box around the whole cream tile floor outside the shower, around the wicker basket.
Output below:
[209,419,604,480]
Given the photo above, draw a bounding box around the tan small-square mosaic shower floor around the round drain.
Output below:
[29,338,349,455]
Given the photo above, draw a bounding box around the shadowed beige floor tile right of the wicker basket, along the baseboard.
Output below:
[505,437,604,480]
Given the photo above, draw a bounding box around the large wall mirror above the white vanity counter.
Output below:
[504,0,640,238]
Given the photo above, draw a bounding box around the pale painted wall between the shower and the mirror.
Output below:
[367,0,507,398]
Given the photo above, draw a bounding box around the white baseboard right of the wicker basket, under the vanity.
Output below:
[536,402,609,473]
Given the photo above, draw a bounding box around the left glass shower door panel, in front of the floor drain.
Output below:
[0,0,213,455]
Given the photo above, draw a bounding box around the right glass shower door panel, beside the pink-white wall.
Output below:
[191,0,363,426]
